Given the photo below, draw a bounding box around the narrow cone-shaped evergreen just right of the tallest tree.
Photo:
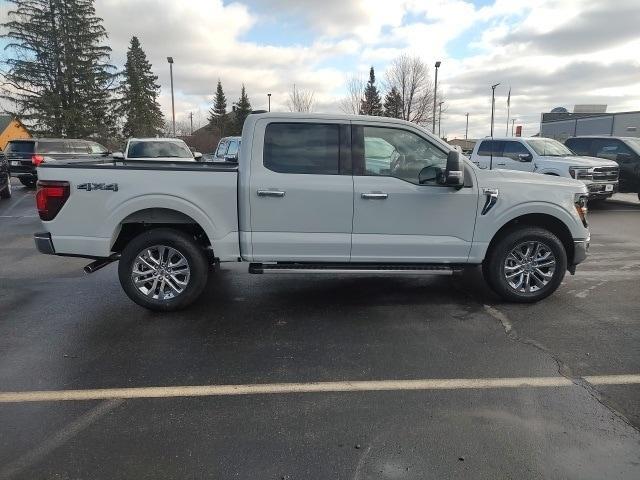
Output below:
[119,36,164,137]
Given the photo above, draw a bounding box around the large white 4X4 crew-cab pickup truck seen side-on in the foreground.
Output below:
[35,113,589,310]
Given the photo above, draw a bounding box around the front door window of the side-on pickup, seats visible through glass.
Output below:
[364,127,447,185]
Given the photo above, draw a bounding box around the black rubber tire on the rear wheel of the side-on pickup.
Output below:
[118,228,209,312]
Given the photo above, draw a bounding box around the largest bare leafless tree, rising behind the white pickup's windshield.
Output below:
[386,54,440,125]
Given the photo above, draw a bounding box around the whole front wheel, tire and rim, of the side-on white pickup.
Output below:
[482,227,567,303]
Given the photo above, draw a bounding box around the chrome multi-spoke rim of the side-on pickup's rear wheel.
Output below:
[131,245,191,300]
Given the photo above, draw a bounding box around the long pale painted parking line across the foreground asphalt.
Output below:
[0,375,640,403]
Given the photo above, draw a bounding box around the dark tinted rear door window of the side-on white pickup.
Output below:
[263,123,340,175]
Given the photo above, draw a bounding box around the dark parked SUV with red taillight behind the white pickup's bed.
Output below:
[5,138,111,188]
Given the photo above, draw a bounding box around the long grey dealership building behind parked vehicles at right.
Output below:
[540,105,640,141]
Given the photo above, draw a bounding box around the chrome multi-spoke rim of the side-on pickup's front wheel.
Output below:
[503,241,556,293]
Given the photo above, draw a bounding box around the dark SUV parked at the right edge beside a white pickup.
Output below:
[564,137,640,200]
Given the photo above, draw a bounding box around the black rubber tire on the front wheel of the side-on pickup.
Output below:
[482,226,567,303]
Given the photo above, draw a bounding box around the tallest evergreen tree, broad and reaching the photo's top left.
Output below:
[2,0,116,138]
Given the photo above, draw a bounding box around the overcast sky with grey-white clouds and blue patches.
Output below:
[3,0,640,138]
